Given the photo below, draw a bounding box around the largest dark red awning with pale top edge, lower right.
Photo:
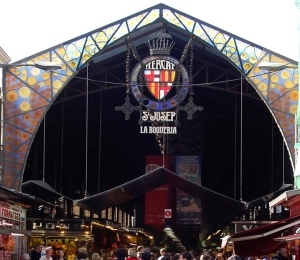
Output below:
[230,216,300,257]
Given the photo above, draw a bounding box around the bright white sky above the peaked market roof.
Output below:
[0,0,300,62]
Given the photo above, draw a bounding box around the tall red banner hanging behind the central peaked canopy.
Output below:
[145,155,171,226]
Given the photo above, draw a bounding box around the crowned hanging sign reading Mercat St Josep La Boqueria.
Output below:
[116,32,203,134]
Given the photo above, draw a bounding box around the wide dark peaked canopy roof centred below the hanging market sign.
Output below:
[76,168,246,215]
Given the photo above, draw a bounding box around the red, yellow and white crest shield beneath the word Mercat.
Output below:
[144,69,176,100]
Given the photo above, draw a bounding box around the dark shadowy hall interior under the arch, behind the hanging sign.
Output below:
[23,18,292,211]
